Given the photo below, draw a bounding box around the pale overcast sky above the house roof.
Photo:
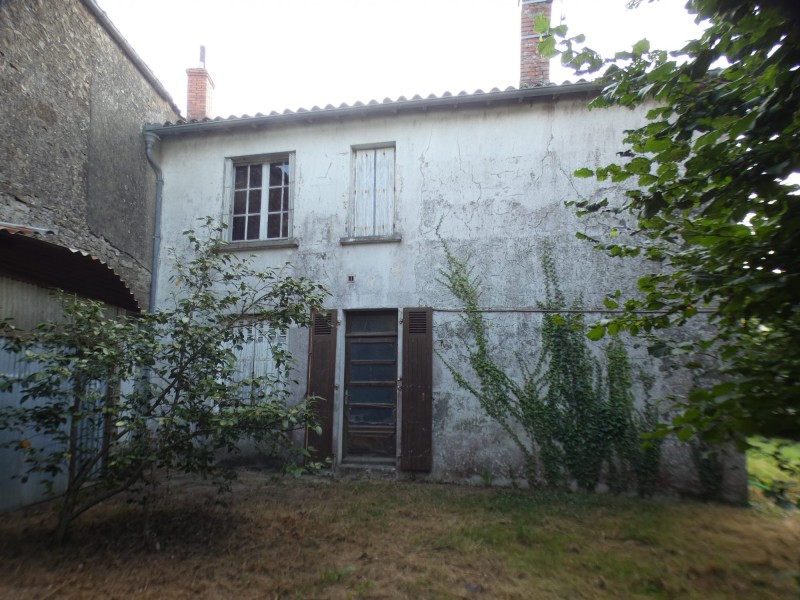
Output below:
[96,0,697,116]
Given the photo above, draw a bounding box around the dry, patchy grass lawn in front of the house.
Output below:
[0,471,800,600]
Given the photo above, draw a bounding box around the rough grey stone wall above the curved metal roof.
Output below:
[0,0,176,307]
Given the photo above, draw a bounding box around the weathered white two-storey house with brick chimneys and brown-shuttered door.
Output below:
[145,0,746,500]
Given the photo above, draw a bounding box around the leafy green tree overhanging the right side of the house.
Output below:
[541,0,800,441]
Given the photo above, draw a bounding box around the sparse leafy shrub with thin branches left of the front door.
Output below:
[0,220,325,541]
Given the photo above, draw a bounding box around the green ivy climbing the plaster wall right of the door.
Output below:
[441,240,661,495]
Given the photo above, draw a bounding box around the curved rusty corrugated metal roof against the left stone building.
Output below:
[0,223,141,312]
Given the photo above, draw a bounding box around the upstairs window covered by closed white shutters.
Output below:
[351,145,395,238]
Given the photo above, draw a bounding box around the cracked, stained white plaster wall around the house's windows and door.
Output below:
[159,92,737,496]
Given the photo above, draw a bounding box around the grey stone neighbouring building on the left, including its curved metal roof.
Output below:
[0,0,180,510]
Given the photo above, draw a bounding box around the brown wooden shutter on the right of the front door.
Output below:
[400,308,433,471]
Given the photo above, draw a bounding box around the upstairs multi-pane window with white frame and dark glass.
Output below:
[230,154,294,242]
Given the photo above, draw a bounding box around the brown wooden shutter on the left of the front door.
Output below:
[306,310,336,460]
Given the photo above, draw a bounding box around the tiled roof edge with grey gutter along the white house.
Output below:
[144,80,602,136]
